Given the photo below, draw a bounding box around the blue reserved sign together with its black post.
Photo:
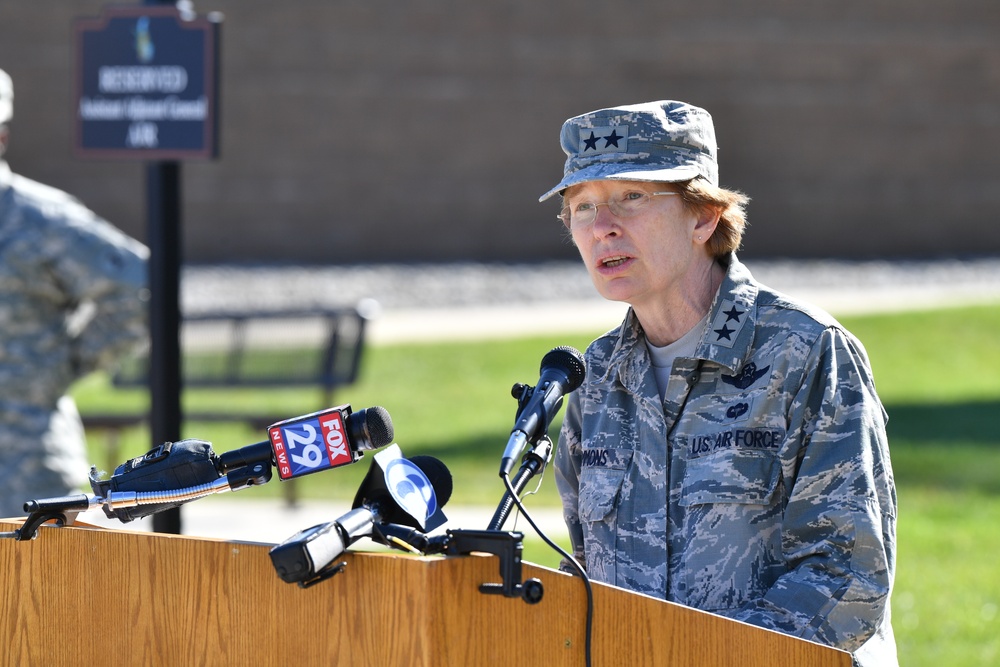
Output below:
[74,0,221,533]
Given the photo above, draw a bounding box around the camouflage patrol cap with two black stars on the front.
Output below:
[538,100,719,201]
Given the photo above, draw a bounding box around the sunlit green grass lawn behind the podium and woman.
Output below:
[74,307,1000,667]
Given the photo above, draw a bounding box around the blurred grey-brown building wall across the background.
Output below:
[0,0,1000,263]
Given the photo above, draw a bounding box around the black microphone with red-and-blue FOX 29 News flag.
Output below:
[216,405,395,480]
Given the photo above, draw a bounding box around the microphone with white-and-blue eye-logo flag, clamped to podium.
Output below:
[268,445,452,587]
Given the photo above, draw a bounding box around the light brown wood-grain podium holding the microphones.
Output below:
[0,520,851,667]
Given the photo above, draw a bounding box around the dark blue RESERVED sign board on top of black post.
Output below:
[74,6,220,160]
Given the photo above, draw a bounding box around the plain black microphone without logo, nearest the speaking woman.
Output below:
[500,346,587,477]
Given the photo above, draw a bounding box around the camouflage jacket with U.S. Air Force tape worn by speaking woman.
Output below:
[555,256,897,667]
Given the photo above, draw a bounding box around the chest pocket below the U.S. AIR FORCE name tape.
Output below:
[679,451,781,507]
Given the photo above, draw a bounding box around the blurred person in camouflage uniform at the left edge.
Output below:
[0,70,149,517]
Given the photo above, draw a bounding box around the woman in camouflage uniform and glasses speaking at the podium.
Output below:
[541,101,897,667]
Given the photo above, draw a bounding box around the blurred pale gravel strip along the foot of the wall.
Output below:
[181,258,1000,314]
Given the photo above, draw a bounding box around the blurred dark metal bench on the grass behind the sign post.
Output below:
[81,301,377,503]
